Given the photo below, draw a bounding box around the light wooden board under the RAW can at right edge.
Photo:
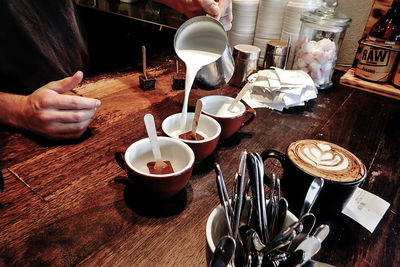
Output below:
[339,68,400,100]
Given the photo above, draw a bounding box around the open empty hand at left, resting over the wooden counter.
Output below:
[12,71,101,139]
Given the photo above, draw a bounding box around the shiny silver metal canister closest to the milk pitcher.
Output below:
[229,44,261,87]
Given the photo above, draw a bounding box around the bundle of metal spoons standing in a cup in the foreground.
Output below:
[210,151,329,267]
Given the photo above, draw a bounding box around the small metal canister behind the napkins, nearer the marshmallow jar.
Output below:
[263,41,288,69]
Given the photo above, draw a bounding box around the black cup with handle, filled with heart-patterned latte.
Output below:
[261,139,367,220]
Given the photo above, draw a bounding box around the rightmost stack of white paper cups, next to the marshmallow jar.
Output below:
[280,0,322,69]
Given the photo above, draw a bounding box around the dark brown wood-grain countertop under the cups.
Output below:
[0,66,400,266]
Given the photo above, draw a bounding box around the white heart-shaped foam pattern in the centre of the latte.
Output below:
[298,144,349,171]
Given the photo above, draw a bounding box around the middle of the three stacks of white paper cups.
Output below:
[253,0,287,66]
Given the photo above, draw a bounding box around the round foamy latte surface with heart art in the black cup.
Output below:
[287,139,365,182]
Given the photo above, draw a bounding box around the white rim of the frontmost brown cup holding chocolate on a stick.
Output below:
[124,136,195,178]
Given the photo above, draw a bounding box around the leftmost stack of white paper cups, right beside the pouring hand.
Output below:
[228,0,259,47]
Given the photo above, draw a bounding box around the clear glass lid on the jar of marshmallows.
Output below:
[301,0,351,28]
